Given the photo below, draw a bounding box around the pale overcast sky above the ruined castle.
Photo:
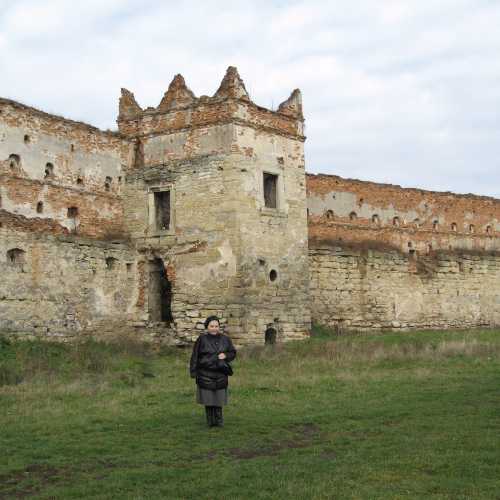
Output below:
[0,0,500,197]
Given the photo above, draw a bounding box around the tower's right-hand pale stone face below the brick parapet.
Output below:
[234,121,311,342]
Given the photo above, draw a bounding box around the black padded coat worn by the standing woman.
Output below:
[189,333,236,391]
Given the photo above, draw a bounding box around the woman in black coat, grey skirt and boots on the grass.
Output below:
[189,316,236,427]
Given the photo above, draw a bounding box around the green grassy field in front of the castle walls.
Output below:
[0,328,500,499]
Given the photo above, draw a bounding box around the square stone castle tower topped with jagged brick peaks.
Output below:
[118,67,310,344]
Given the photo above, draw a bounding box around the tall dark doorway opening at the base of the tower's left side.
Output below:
[149,258,173,323]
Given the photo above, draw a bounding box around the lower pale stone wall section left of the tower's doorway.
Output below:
[0,228,137,337]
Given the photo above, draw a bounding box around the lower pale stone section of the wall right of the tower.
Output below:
[310,244,500,329]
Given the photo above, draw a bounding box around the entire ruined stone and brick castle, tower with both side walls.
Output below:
[0,67,500,344]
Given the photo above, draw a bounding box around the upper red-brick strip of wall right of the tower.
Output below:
[307,175,500,255]
